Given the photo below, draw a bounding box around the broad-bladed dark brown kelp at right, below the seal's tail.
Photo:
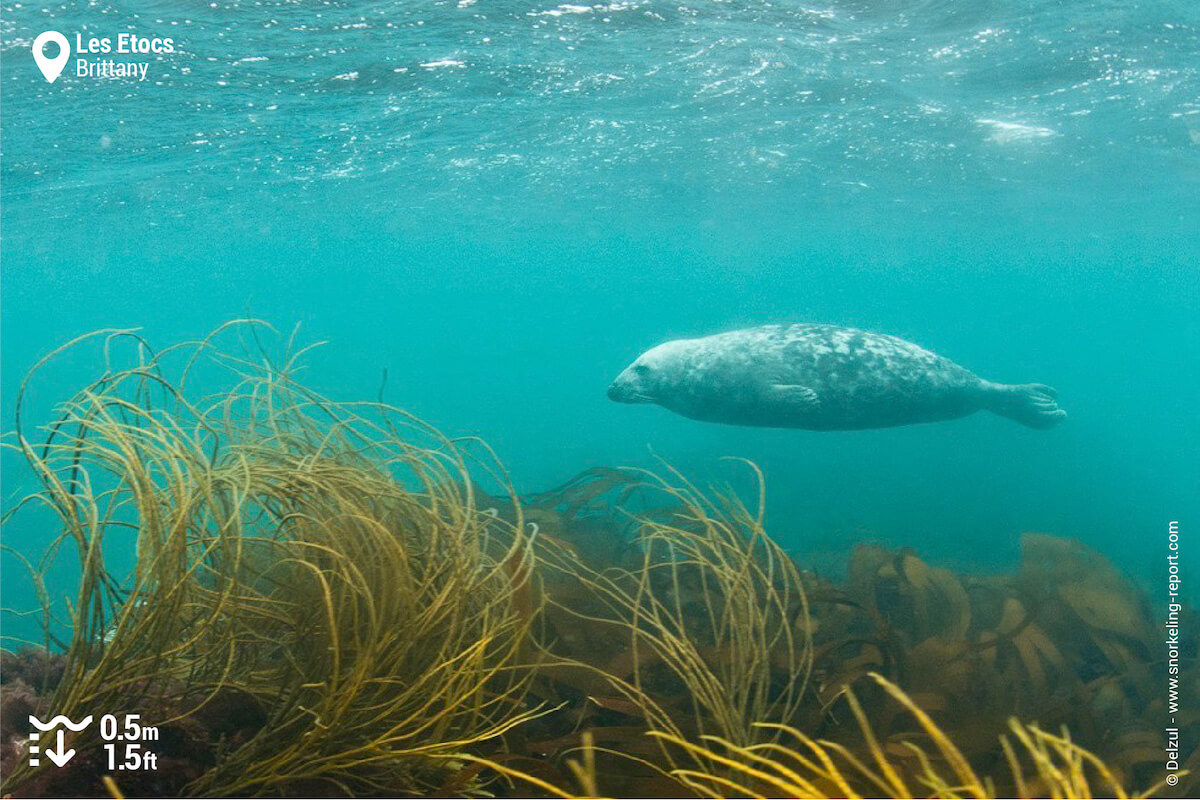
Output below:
[816,534,1185,786]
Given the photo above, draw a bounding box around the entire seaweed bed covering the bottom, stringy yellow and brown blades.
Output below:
[0,320,1200,796]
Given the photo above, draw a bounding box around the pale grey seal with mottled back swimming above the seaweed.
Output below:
[608,324,1067,431]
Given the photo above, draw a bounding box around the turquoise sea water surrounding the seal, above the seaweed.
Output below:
[0,0,1200,631]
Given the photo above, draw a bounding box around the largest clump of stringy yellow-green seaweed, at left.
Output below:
[5,323,530,795]
